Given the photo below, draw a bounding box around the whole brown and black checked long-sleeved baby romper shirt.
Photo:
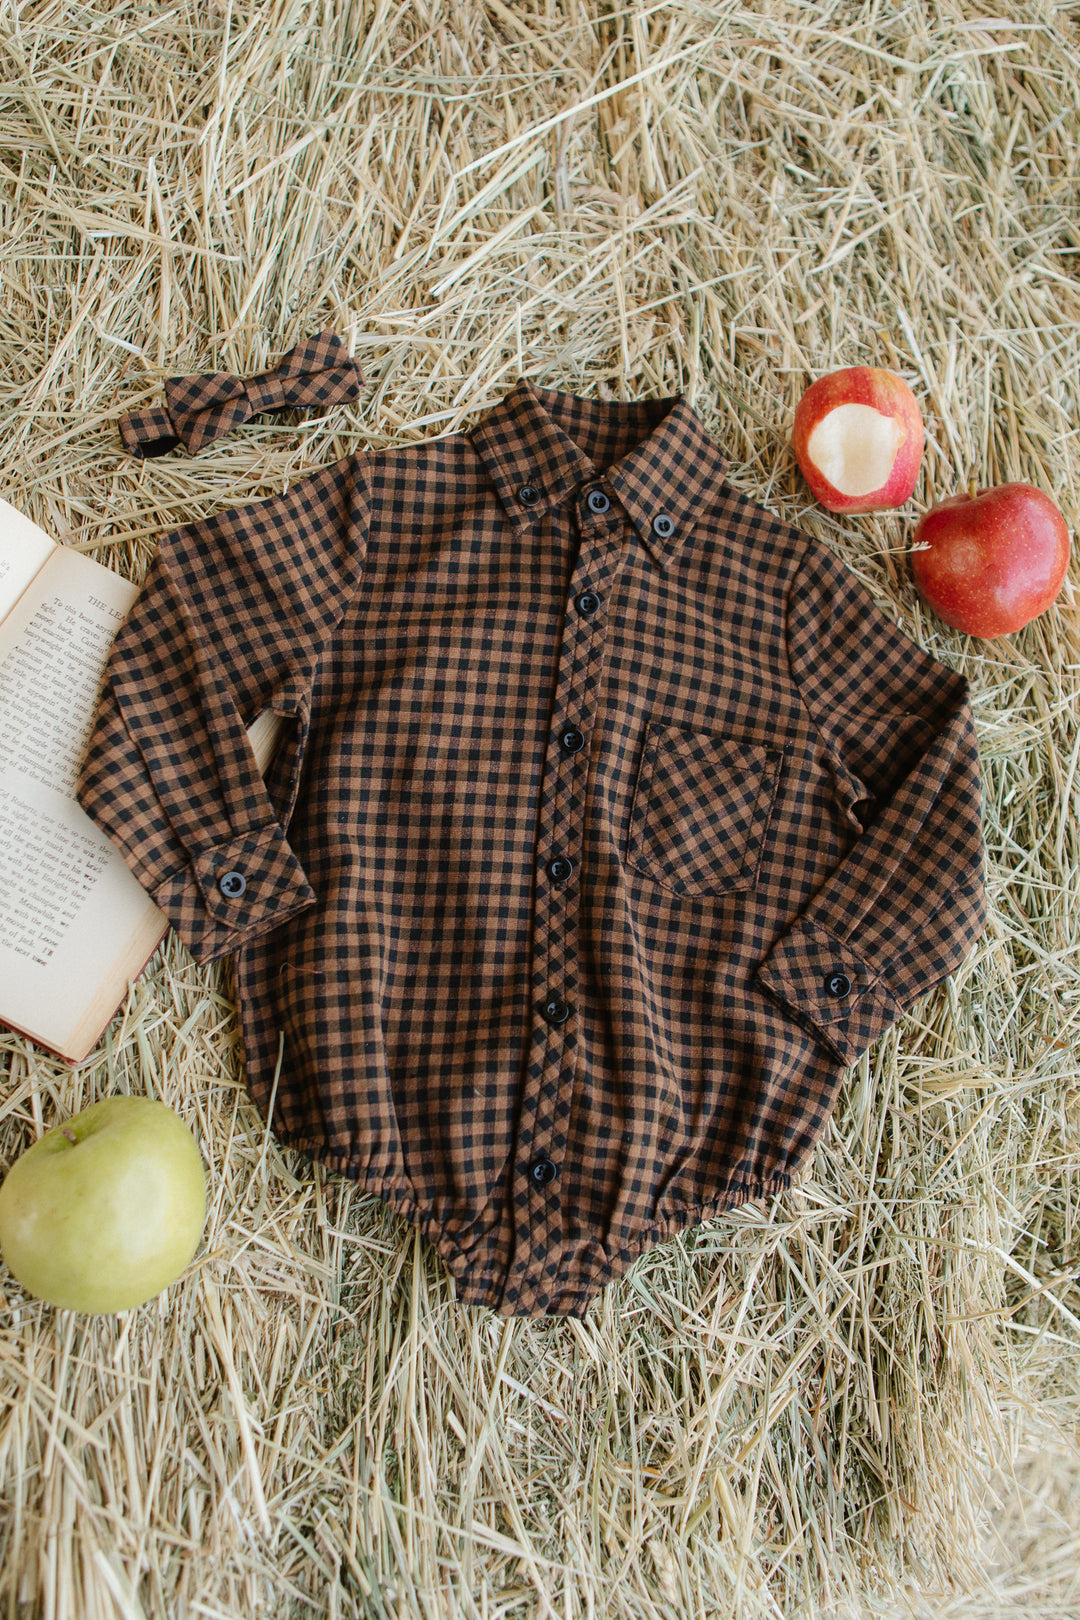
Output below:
[79,382,983,1315]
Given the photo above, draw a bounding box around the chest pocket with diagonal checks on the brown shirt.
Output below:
[627,723,789,894]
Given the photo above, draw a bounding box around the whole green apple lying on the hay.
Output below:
[0,1097,206,1312]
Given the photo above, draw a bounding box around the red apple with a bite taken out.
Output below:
[792,366,923,512]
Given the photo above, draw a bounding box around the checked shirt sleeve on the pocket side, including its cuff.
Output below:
[758,544,986,1064]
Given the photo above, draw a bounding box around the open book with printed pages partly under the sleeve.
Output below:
[0,501,280,1063]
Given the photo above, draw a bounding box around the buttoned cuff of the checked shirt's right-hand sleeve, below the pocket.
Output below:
[758,927,902,1068]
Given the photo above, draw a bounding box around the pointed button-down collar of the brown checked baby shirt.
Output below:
[470,377,727,567]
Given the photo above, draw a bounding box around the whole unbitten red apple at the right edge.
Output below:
[912,484,1069,642]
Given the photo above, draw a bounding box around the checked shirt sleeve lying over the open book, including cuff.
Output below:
[76,457,368,962]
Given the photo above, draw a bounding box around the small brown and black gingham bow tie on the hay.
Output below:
[120,332,364,458]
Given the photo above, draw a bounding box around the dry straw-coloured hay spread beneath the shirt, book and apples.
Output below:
[0,0,1080,1620]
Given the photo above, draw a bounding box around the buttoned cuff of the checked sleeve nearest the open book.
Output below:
[154,823,317,962]
